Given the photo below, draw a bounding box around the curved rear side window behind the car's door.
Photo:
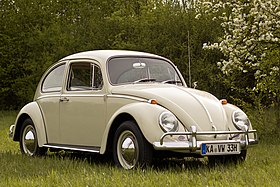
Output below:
[42,64,65,92]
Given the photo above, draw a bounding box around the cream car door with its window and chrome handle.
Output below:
[60,60,106,147]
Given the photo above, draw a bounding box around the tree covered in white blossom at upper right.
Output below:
[196,0,280,103]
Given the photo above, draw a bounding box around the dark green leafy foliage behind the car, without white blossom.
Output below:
[0,0,279,110]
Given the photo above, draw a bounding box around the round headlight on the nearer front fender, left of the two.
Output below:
[159,112,178,132]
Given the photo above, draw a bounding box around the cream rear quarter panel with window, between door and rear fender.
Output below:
[36,62,66,144]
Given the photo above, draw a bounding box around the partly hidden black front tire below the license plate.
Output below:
[208,150,247,165]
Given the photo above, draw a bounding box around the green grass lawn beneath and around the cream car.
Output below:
[0,112,280,187]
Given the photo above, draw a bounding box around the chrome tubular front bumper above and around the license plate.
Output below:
[153,126,258,155]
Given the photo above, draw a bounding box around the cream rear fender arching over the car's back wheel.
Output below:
[13,102,47,147]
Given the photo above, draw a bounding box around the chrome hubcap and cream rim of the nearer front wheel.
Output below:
[117,130,139,169]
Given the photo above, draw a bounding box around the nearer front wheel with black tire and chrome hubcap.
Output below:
[113,121,153,169]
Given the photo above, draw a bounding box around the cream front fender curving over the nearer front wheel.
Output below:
[100,102,172,154]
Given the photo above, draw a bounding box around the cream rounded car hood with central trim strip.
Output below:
[112,83,227,131]
